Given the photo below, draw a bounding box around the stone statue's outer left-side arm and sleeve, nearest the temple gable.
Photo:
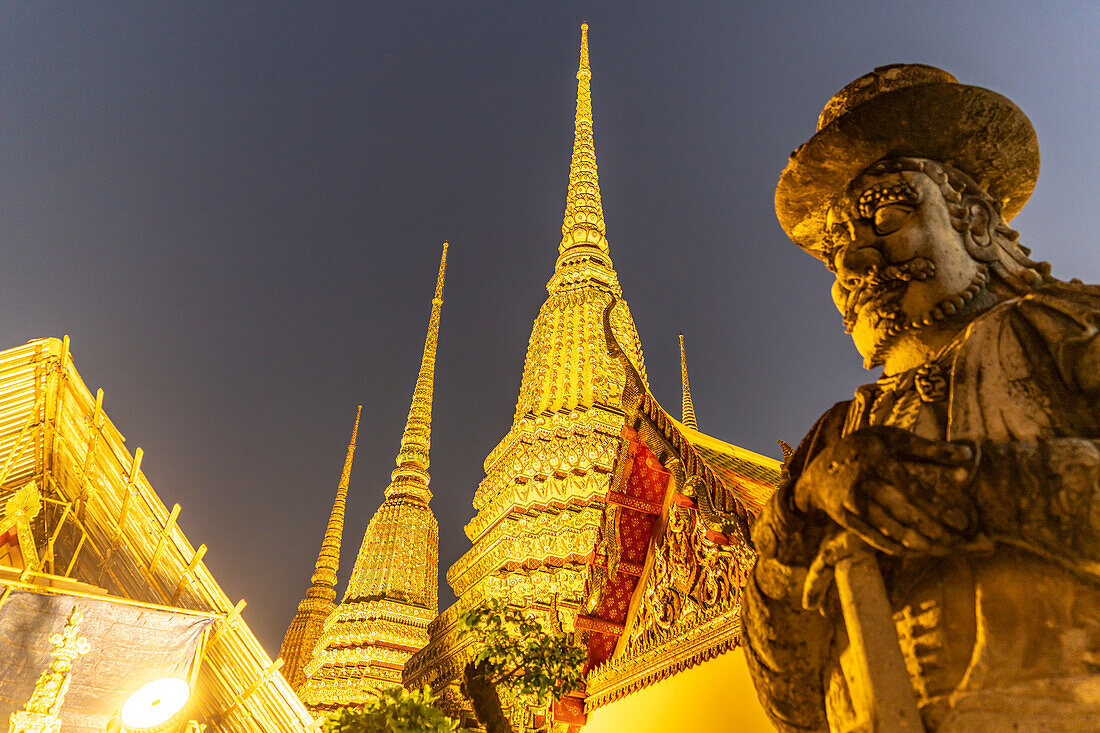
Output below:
[741,403,847,733]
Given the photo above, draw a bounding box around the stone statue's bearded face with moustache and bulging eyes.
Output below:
[827,172,983,368]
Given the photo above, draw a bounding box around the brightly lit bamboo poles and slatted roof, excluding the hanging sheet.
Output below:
[0,339,316,733]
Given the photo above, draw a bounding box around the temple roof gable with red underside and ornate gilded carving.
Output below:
[572,315,781,713]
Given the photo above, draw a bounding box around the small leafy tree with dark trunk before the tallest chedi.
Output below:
[459,600,587,733]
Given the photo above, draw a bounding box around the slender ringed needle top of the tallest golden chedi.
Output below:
[558,23,611,266]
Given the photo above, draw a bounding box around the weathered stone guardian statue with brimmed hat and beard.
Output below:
[743,64,1100,733]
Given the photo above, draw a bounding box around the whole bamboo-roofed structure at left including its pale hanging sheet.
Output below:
[0,337,315,733]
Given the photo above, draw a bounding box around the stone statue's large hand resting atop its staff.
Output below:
[794,427,978,555]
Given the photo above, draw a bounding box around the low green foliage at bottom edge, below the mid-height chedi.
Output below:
[322,683,462,733]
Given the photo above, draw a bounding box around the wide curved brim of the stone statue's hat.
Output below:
[776,84,1040,259]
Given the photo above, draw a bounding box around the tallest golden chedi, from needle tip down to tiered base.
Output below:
[406,25,645,717]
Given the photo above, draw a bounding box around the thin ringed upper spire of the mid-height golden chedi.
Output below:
[386,242,449,502]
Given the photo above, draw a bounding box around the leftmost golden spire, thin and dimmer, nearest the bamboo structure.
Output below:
[279,405,363,690]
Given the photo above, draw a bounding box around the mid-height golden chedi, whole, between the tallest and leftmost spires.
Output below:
[299,242,448,710]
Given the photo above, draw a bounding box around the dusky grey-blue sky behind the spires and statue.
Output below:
[0,0,1100,656]
